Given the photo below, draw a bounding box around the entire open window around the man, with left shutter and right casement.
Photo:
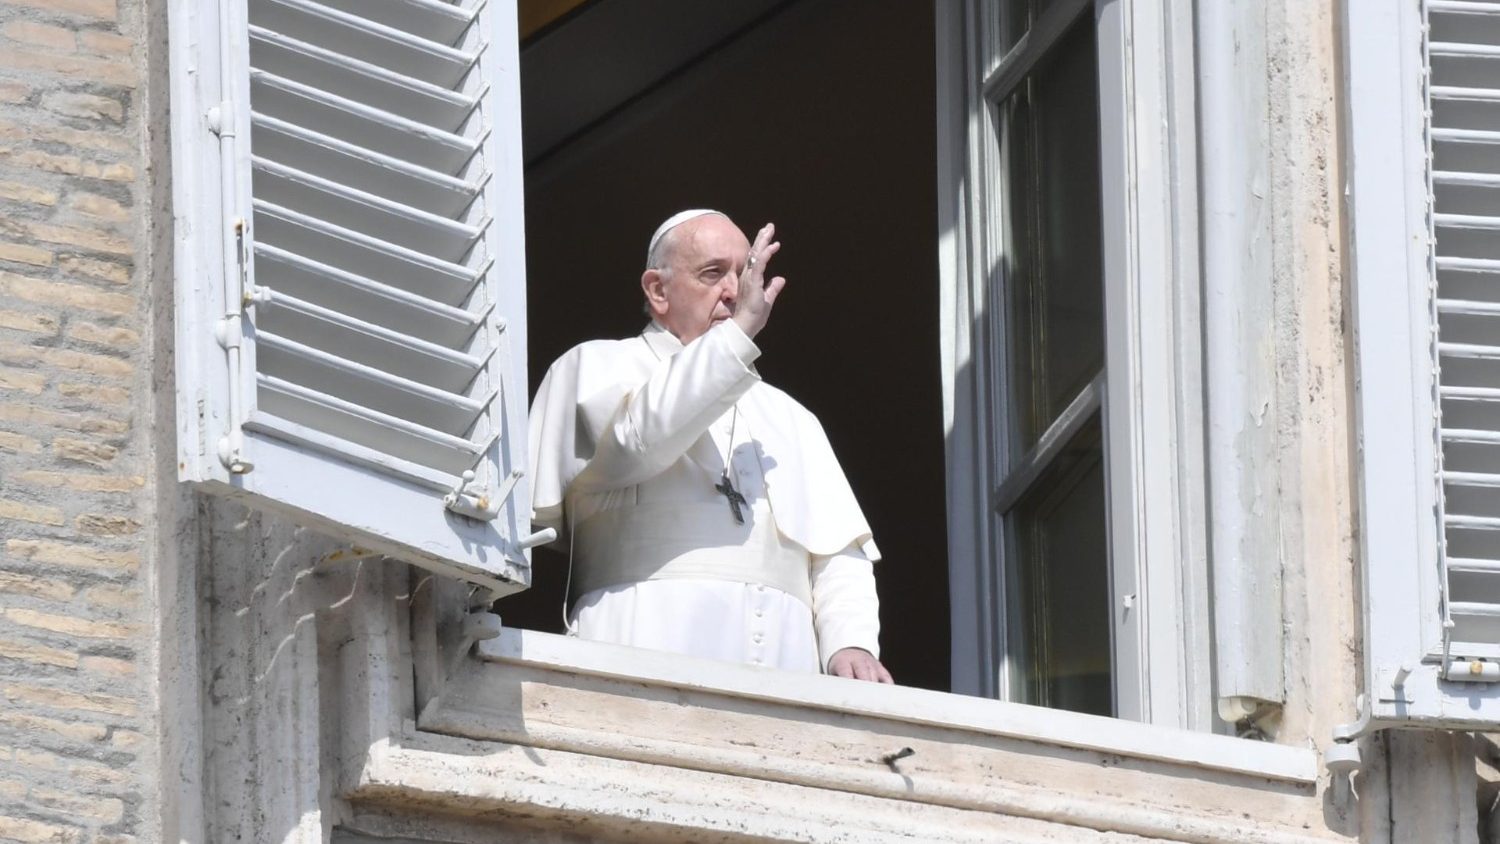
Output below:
[173,0,1254,737]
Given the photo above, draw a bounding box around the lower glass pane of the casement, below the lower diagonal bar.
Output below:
[1007,415,1115,715]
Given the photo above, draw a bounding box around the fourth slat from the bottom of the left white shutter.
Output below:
[255,243,485,349]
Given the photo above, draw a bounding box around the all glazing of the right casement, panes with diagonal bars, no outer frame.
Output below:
[986,3,1115,715]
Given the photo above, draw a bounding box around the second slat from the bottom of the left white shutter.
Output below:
[255,331,494,436]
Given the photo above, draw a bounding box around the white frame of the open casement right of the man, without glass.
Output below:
[938,0,1214,730]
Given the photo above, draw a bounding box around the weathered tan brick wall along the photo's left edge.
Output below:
[0,0,150,843]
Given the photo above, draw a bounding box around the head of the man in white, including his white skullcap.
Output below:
[641,214,750,343]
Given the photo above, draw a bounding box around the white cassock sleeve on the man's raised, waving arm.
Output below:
[573,319,761,492]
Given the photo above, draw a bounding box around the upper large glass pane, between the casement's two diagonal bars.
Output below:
[1001,15,1104,451]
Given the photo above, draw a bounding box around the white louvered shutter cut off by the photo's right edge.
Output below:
[1346,0,1500,729]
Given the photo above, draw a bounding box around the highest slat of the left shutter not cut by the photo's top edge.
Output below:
[251,27,483,132]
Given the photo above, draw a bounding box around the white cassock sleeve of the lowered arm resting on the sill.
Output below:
[812,546,881,672]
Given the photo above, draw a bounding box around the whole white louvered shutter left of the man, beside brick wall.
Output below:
[170,0,539,592]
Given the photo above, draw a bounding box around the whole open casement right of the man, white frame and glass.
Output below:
[939,0,1212,729]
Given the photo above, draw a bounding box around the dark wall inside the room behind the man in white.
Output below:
[500,0,950,690]
